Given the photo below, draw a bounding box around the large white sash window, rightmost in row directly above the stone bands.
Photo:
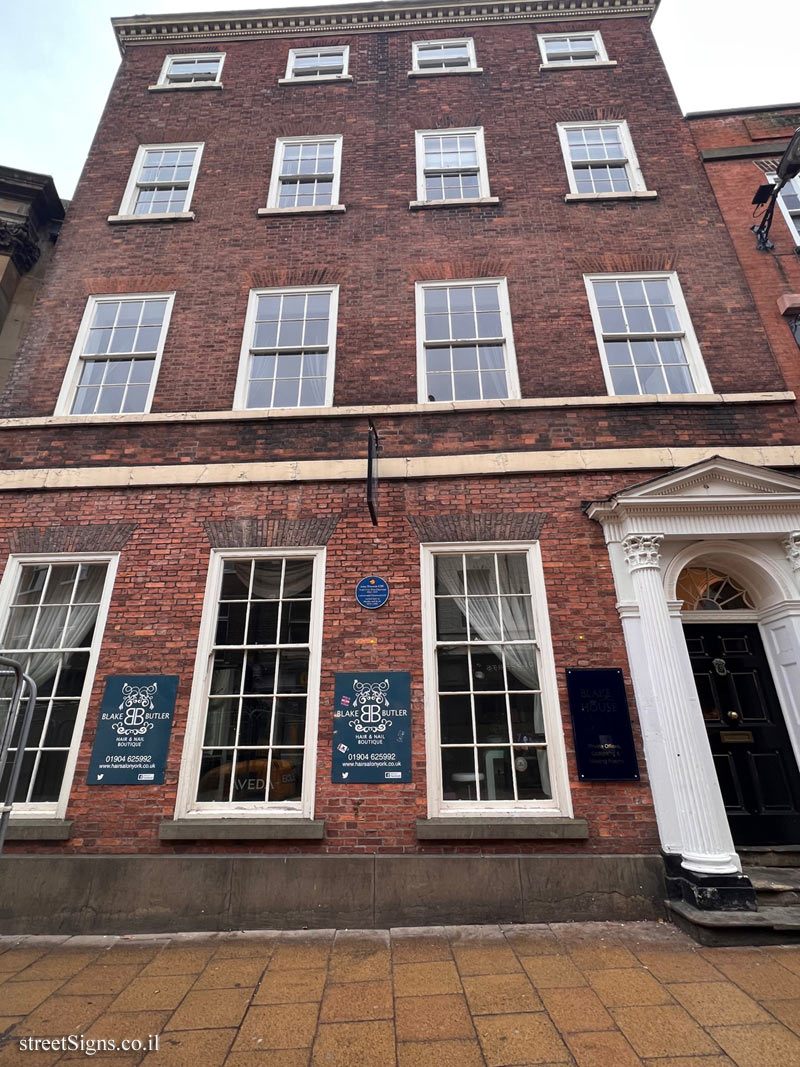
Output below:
[587,273,711,396]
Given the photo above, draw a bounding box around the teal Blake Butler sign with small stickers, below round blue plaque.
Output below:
[331,670,411,784]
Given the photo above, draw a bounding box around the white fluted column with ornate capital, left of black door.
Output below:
[622,534,741,875]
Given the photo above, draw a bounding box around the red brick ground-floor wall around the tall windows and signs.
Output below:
[0,472,657,853]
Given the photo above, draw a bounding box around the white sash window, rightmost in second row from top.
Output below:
[559,122,645,196]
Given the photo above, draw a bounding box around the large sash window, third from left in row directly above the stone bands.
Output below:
[417,278,518,401]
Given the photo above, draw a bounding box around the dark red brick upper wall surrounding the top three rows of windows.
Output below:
[4,18,784,420]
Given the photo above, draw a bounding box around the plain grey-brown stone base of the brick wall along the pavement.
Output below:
[0,855,665,934]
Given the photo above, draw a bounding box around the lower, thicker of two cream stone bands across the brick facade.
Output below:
[0,445,800,490]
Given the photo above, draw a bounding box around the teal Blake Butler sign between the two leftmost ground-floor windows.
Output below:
[86,674,178,785]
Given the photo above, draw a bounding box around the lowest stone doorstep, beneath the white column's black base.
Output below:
[665,901,800,945]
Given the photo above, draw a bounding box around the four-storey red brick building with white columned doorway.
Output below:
[0,0,800,930]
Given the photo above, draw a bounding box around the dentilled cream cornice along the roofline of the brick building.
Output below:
[111,0,659,52]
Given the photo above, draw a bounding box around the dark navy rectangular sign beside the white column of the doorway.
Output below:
[566,667,639,782]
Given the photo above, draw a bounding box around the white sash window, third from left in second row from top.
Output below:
[417,126,489,203]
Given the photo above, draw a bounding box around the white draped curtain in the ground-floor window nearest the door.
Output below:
[437,557,553,796]
